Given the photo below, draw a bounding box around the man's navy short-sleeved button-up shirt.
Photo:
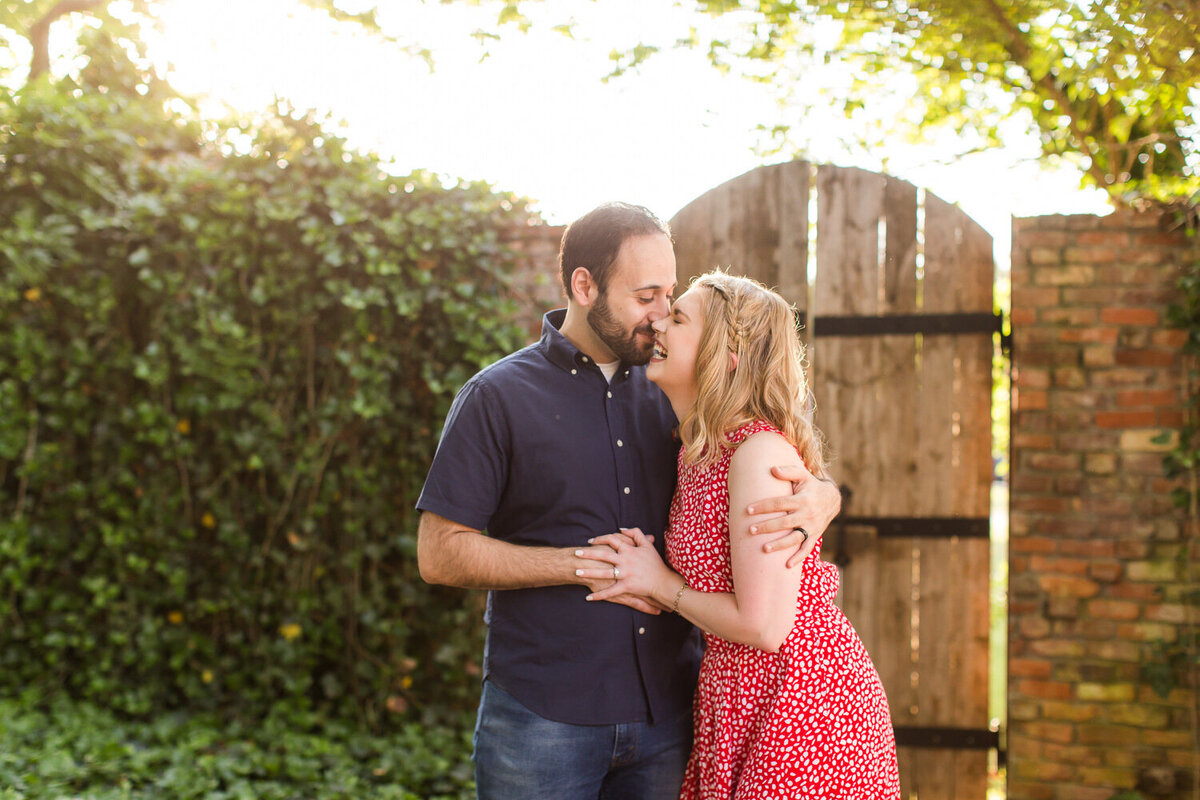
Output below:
[416,309,701,724]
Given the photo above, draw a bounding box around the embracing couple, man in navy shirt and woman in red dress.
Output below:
[418,203,900,800]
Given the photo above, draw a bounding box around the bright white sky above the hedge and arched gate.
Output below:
[142,0,1109,268]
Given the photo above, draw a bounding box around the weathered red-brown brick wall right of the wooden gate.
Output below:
[1008,212,1200,800]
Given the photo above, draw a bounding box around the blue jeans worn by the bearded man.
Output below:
[475,680,691,800]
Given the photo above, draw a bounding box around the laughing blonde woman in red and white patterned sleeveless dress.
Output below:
[582,272,900,800]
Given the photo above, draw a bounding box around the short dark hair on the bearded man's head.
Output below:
[558,203,673,299]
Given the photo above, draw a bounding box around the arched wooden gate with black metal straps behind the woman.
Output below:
[671,161,998,800]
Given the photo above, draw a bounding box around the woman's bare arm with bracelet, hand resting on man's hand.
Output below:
[576,433,803,652]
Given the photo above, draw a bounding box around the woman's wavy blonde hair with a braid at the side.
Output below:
[679,270,826,477]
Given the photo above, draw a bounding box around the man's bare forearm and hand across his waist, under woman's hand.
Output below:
[416,511,660,614]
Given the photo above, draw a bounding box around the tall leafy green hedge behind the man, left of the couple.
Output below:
[0,32,530,722]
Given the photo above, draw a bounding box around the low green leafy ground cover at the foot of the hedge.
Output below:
[0,694,475,800]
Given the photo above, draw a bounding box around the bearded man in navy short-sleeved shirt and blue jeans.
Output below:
[418,203,840,800]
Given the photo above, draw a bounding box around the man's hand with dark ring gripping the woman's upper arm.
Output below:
[746,465,841,567]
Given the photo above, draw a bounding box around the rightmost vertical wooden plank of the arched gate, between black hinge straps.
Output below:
[914,194,992,800]
